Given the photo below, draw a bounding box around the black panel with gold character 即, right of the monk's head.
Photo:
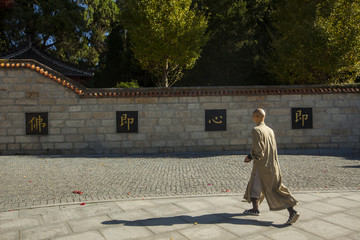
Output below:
[291,108,313,129]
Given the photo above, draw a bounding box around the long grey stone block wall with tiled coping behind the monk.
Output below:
[0,61,360,154]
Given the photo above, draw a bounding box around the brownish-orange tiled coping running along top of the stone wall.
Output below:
[0,60,360,98]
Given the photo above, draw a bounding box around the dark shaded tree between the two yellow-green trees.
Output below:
[180,0,272,86]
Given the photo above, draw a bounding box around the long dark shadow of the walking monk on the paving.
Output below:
[102,213,289,228]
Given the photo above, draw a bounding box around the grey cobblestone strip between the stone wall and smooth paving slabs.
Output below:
[0,152,360,211]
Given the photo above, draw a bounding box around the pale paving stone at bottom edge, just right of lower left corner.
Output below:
[21,223,71,240]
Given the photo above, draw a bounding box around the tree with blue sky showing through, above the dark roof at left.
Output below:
[0,0,118,67]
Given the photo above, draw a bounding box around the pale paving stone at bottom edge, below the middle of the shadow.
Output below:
[178,225,238,240]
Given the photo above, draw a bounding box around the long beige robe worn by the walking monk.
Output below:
[244,123,297,211]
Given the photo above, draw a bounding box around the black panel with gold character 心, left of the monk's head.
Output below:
[205,109,226,131]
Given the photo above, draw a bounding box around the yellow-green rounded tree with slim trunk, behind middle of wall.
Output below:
[121,0,208,87]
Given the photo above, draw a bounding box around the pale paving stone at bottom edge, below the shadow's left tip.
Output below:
[99,226,154,240]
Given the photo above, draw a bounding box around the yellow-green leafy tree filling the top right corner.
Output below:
[265,0,360,84]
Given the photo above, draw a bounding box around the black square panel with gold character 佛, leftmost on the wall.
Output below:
[25,112,49,135]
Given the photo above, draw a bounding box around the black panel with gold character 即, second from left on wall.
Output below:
[116,111,139,133]
